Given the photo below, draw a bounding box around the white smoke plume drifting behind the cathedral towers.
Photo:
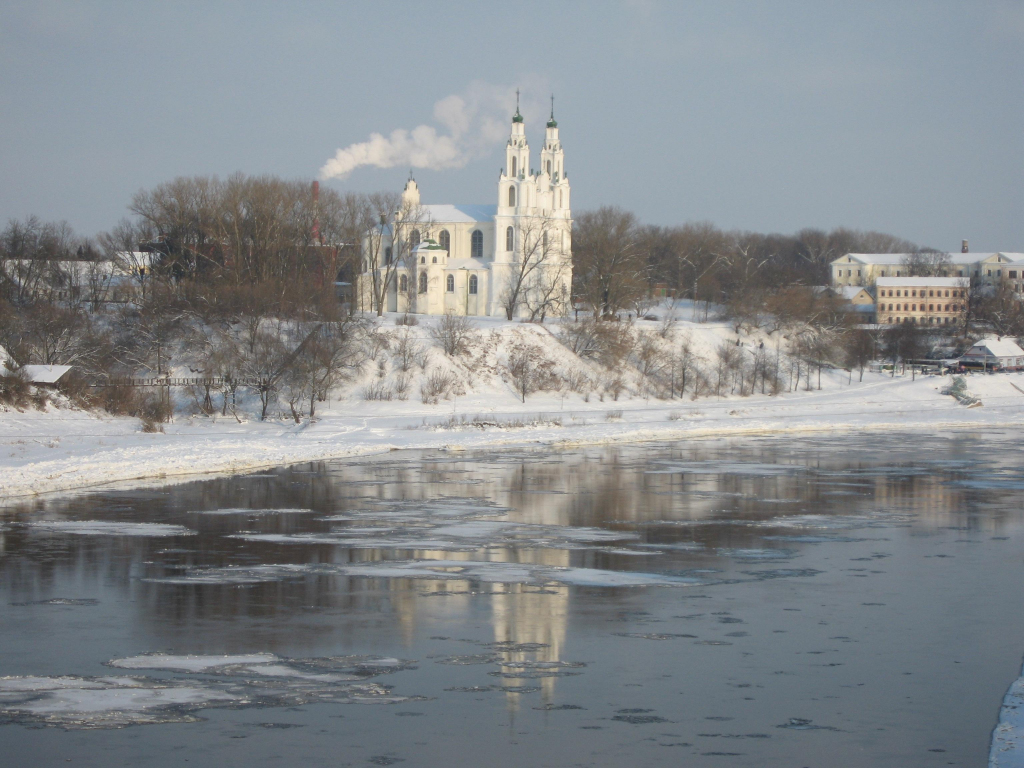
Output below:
[319,78,548,179]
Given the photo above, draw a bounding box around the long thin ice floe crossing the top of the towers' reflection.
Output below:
[145,560,707,587]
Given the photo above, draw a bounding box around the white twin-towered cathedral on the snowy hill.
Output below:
[359,98,572,319]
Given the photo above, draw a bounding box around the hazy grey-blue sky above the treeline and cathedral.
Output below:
[0,0,1024,251]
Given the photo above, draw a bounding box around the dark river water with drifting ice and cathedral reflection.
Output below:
[0,432,1024,768]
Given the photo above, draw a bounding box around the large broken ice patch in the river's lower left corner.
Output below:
[0,653,423,728]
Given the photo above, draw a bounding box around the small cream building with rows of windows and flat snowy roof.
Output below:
[876,278,968,326]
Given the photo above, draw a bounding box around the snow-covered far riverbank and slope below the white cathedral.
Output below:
[0,309,1024,501]
